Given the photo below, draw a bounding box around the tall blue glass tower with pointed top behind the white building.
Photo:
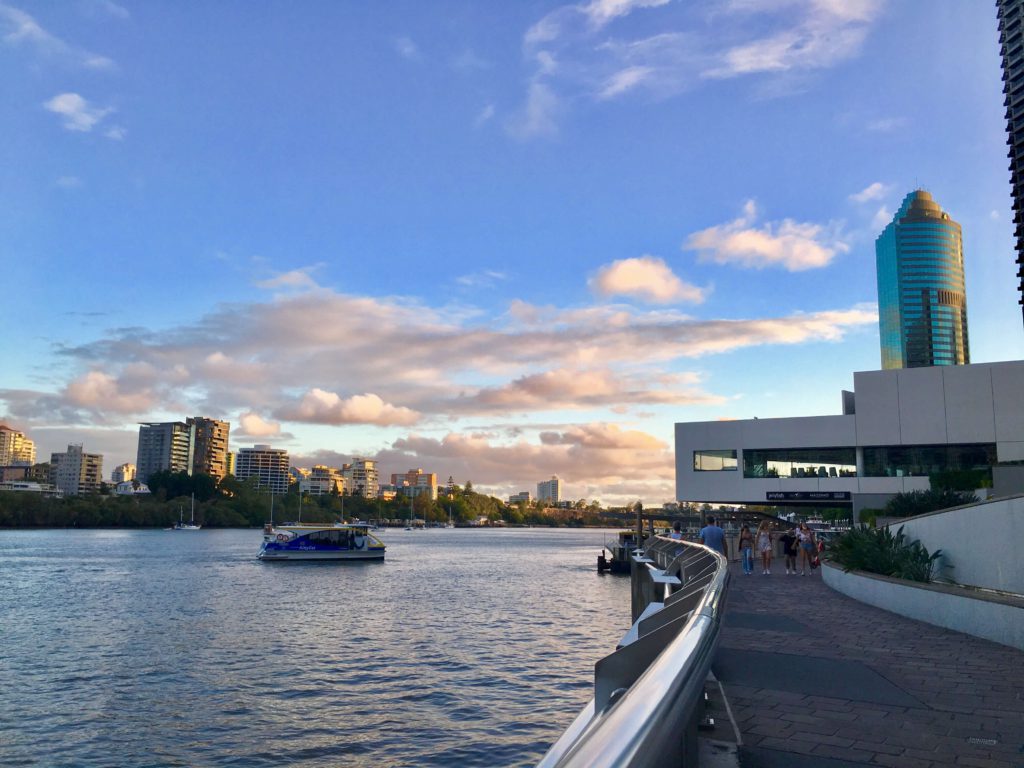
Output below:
[874,189,971,369]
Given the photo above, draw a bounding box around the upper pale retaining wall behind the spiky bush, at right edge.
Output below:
[889,496,1024,595]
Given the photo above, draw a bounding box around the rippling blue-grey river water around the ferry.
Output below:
[0,528,629,768]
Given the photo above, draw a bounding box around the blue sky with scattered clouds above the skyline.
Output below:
[0,0,1024,505]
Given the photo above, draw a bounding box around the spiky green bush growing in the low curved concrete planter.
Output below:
[829,525,942,583]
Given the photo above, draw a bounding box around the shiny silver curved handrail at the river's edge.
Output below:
[538,537,729,768]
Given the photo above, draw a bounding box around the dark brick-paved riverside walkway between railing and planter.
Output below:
[714,564,1024,768]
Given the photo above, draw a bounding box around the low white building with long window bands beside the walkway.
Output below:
[676,360,1024,513]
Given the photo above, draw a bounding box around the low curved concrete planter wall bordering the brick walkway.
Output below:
[821,562,1024,650]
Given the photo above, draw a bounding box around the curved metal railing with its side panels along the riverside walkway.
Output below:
[539,537,729,768]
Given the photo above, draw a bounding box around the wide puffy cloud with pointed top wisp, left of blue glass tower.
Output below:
[683,200,850,272]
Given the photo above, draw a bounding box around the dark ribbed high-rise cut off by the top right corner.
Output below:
[995,0,1024,321]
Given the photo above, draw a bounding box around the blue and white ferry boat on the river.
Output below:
[256,522,385,561]
